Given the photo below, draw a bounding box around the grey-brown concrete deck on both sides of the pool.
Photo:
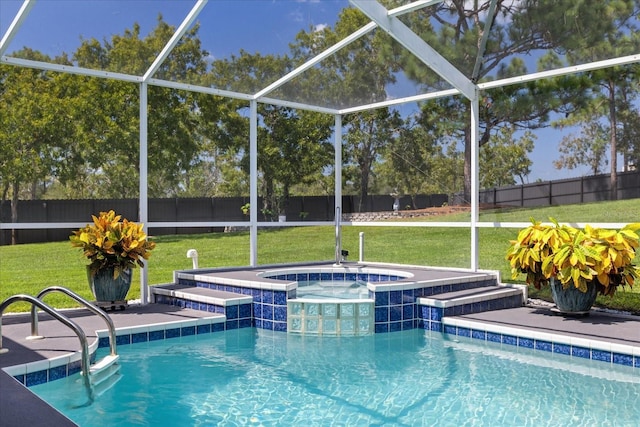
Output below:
[0,304,640,426]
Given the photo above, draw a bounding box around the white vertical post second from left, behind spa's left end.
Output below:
[249,99,258,267]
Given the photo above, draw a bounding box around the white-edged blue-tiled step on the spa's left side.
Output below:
[150,283,253,329]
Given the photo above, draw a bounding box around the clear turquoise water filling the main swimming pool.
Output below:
[31,328,640,427]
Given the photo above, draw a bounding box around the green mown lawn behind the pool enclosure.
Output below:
[0,199,640,313]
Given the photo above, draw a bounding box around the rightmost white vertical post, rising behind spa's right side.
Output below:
[469,88,480,271]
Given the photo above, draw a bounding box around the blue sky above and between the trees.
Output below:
[0,0,588,182]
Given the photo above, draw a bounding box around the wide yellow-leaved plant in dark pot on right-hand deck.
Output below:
[506,218,640,313]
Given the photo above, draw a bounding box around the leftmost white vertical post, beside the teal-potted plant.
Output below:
[138,82,149,305]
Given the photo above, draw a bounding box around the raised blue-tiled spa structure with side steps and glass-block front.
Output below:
[151,263,523,336]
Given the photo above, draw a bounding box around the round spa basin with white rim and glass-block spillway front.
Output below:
[258,266,413,336]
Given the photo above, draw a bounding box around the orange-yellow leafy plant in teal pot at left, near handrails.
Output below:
[69,210,156,304]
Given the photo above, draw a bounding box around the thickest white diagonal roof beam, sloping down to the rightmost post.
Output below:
[349,0,476,99]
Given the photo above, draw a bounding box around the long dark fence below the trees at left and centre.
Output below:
[0,194,448,245]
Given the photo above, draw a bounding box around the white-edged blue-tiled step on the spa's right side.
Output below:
[418,285,526,331]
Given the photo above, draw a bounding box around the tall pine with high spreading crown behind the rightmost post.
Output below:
[392,0,633,206]
